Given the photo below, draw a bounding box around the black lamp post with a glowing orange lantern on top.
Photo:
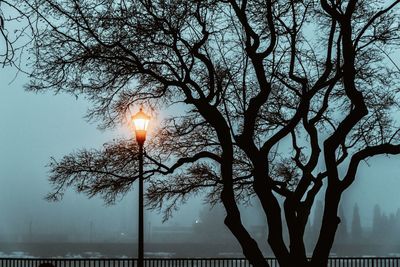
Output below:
[132,108,150,267]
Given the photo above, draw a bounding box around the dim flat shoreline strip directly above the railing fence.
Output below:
[0,242,400,258]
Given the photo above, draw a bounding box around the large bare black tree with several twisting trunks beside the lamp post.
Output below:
[29,0,400,266]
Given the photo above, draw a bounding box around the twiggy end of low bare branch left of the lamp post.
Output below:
[47,140,138,204]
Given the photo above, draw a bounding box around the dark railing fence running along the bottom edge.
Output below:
[0,257,400,267]
